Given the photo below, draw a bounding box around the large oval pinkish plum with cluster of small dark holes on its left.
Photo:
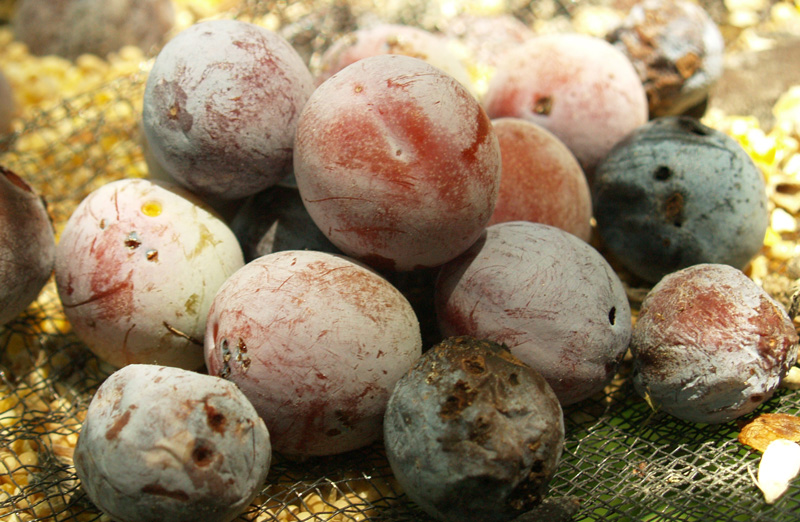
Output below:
[205,250,422,456]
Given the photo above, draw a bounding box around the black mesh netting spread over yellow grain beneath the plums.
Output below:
[0,2,800,522]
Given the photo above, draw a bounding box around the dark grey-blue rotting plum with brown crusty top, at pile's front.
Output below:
[384,337,564,522]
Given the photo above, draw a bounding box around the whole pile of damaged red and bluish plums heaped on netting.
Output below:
[0,2,797,521]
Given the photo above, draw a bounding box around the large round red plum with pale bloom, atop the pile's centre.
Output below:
[294,55,501,271]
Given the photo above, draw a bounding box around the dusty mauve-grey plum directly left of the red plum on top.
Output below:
[142,20,314,199]
